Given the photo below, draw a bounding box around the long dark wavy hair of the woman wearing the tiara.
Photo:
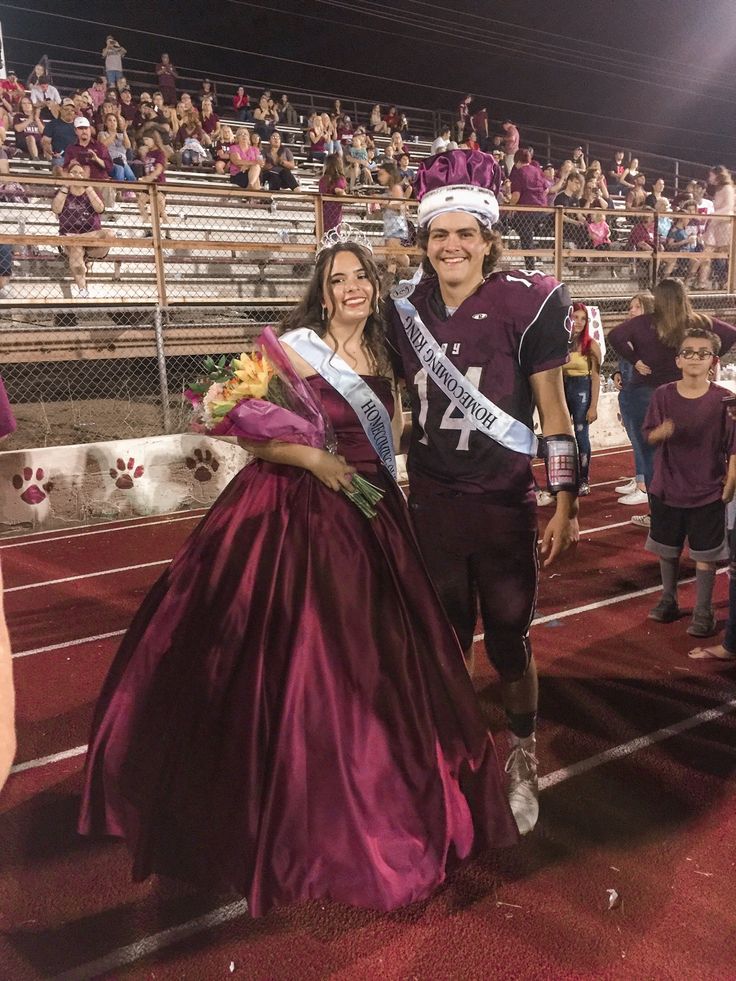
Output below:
[278,242,391,376]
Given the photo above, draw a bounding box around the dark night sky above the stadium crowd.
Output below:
[0,0,736,166]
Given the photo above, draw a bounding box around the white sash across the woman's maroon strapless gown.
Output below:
[279,327,398,480]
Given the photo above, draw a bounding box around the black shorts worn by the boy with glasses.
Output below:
[646,494,728,562]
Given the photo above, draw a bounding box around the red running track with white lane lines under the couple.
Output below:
[0,451,736,981]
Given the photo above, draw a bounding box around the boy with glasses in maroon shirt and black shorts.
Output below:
[642,327,736,637]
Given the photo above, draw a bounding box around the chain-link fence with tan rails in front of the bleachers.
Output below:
[0,178,736,450]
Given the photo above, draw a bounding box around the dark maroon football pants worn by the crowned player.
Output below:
[409,494,538,681]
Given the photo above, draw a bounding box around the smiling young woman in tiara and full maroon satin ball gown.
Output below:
[79,243,517,916]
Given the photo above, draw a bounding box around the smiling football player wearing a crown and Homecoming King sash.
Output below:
[387,150,578,834]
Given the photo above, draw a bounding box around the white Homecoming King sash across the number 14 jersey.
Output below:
[391,283,537,456]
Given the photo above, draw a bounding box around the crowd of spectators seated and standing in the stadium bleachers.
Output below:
[0,42,734,295]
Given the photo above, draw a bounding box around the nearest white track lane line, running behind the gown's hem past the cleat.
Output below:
[43,698,736,981]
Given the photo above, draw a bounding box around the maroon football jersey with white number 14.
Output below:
[387,271,570,504]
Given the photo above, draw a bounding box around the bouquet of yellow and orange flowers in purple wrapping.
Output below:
[184,327,383,518]
